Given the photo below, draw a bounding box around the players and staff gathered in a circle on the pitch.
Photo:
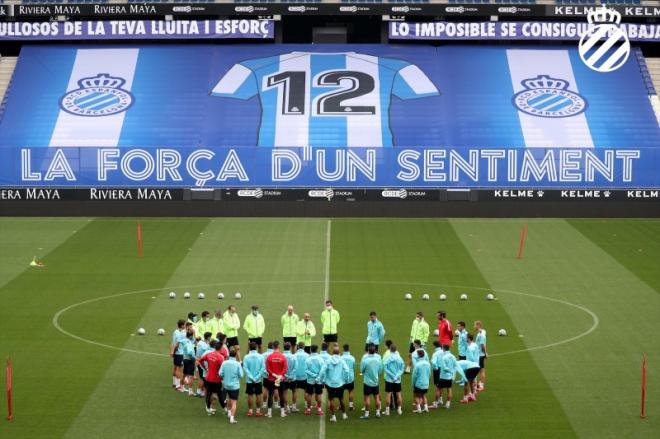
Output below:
[170,300,488,424]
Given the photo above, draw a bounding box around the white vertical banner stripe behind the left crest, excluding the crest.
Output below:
[49,49,139,146]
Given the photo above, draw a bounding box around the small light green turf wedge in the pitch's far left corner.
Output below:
[0,218,91,287]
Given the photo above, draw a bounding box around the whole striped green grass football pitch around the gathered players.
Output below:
[0,218,660,439]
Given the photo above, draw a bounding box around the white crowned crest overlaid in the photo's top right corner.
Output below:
[578,5,630,73]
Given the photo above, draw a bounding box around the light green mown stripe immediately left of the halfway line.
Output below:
[67,219,327,438]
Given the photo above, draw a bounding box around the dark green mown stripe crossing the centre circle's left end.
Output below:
[0,220,209,438]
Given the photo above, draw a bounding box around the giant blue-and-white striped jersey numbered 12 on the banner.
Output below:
[213,52,438,147]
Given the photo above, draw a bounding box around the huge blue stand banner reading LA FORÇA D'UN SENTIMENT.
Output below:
[0,45,660,187]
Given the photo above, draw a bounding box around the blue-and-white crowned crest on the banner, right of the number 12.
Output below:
[512,75,587,118]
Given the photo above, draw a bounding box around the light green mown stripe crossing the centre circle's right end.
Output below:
[452,220,660,438]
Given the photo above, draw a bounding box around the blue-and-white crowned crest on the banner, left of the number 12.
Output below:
[60,73,133,117]
